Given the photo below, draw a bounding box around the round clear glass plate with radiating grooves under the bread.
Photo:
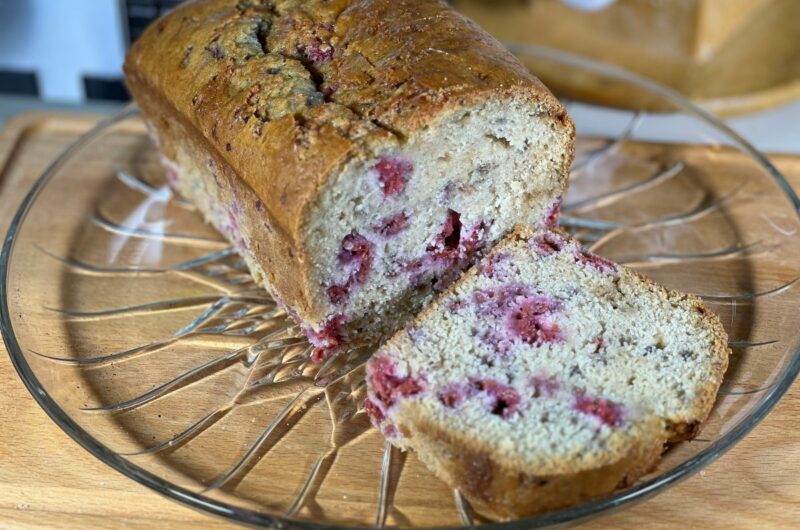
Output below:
[0,46,800,529]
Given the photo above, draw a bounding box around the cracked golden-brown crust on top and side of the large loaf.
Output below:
[125,0,574,317]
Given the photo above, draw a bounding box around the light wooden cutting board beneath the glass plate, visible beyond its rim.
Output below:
[0,114,800,530]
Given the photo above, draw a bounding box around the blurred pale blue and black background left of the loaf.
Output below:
[0,0,180,103]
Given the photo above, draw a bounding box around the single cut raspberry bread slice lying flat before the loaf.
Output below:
[366,228,729,519]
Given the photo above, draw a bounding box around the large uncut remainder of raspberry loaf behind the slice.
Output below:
[125,0,574,358]
